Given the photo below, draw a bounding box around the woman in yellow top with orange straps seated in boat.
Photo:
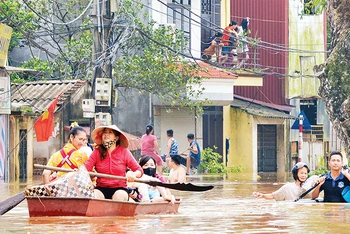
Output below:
[42,126,88,184]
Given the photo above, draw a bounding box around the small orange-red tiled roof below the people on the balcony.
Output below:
[197,62,238,79]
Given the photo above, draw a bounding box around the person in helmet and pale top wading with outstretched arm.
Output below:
[253,162,310,201]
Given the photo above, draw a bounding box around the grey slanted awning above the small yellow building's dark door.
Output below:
[231,98,298,119]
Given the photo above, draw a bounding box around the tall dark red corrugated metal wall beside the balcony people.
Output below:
[231,0,289,105]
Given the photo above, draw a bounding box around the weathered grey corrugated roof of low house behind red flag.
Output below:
[11,80,87,113]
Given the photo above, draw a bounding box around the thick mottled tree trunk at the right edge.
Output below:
[314,0,350,155]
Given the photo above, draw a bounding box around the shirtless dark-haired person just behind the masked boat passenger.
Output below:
[168,154,186,183]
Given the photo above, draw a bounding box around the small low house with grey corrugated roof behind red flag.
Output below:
[8,80,90,180]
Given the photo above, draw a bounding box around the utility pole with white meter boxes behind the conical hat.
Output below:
[90,0,112,131]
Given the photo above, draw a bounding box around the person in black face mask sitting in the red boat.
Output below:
[128,155,175,203]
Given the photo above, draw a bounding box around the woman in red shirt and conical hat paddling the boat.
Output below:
[85,125,143,201]
